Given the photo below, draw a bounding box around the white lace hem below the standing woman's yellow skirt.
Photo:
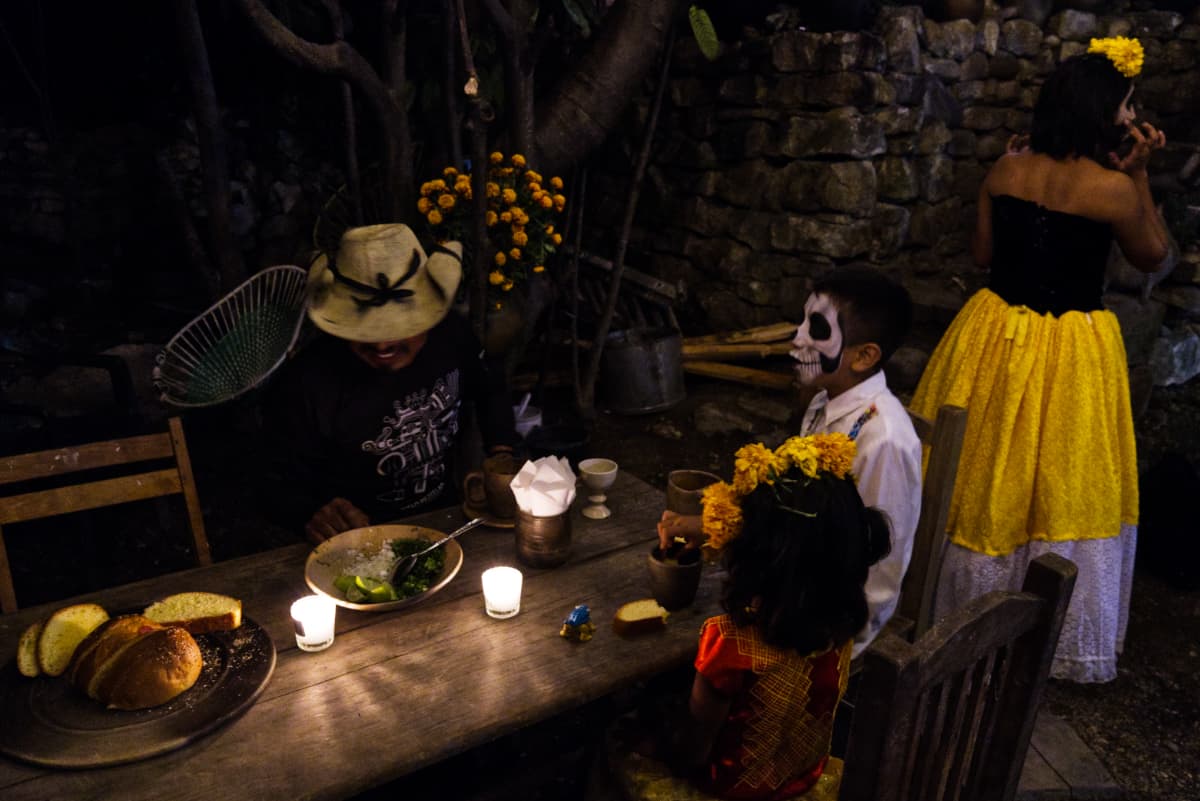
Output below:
[934,525,1138,682]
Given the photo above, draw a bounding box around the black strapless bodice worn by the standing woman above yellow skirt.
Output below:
[988,194,1112,317]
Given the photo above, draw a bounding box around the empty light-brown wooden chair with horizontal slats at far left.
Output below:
[0,417,212,613]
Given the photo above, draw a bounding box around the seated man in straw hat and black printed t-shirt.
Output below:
[264,224,516,542]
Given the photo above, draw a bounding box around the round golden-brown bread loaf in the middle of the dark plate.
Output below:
[67,615,204,709]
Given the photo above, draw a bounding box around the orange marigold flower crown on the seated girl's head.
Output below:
[701,433,857,550]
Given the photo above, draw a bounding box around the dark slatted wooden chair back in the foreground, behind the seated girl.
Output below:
[839,554,1076,801]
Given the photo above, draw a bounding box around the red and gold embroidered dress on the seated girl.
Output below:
[694,615,851,801]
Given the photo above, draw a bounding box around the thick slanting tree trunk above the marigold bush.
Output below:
[535,0,683,175]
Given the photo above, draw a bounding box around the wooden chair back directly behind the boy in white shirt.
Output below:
[896,405,967,638]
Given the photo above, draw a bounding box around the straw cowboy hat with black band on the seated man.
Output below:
[308,223,462,342]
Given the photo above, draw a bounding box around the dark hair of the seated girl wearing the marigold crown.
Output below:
[721,468,890,654]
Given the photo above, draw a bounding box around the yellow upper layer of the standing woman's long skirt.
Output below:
[912,289,1138,556]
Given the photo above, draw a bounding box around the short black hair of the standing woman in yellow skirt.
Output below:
[1030,53,1133,159]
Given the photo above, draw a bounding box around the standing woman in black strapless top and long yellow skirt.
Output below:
[912,37,1168,681]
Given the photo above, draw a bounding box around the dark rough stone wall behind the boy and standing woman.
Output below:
[589,6,1200,330]
